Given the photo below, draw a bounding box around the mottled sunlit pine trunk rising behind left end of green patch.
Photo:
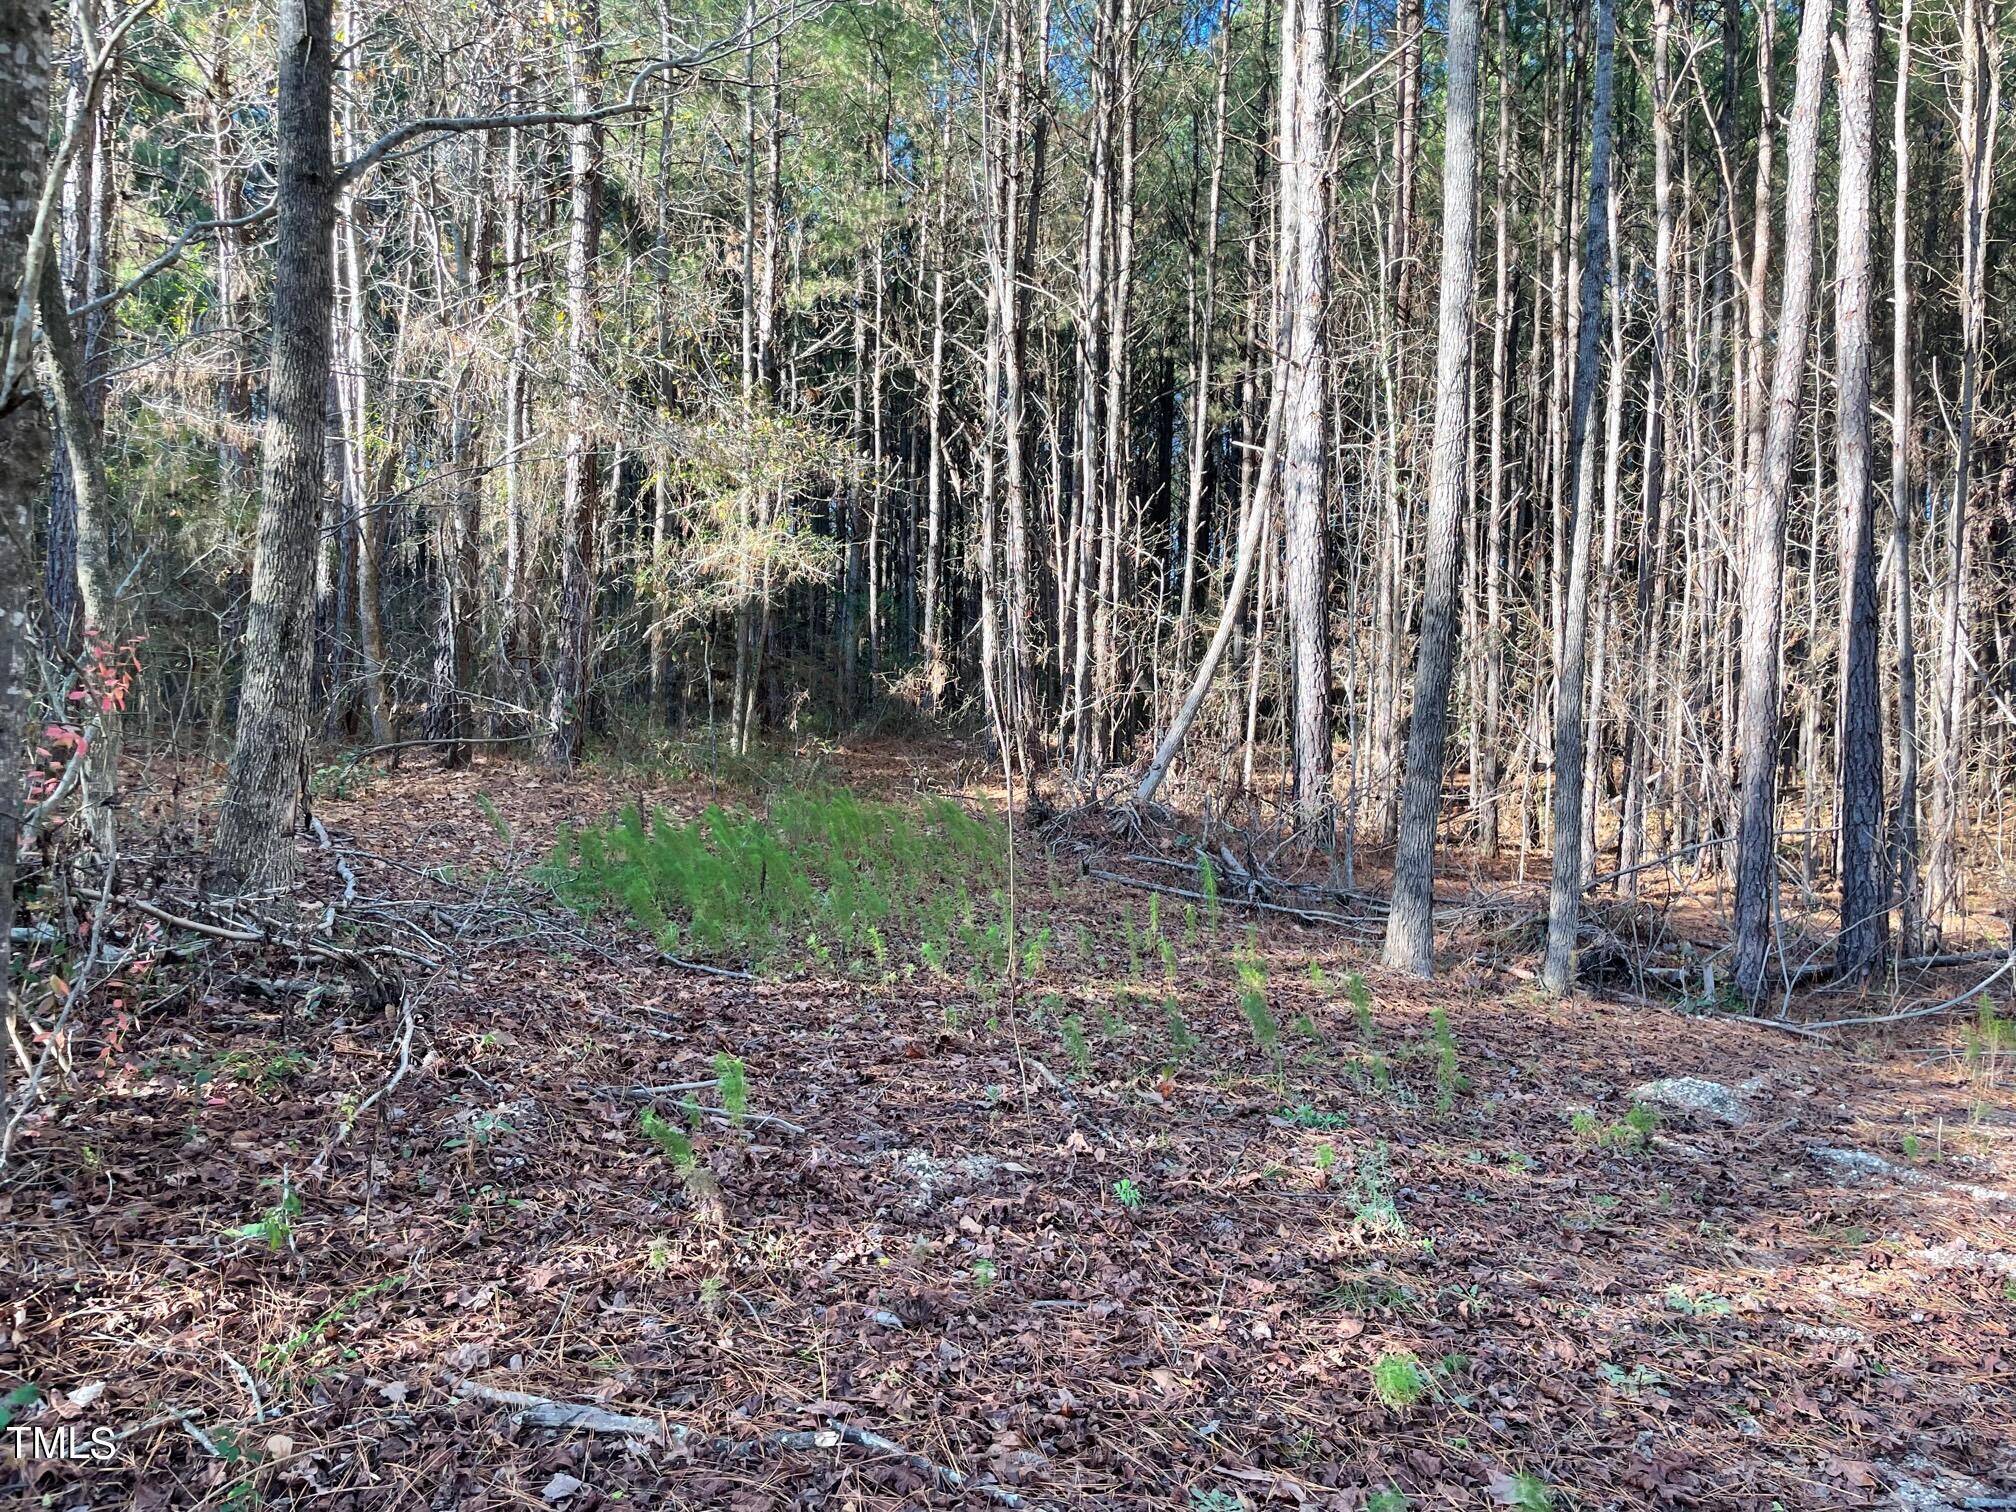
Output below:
[546,0,603,764]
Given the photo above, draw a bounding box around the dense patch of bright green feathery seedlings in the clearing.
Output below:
[546,788,1006,970]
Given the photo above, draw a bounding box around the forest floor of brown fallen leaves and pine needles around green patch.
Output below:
[0,746,2016,1512]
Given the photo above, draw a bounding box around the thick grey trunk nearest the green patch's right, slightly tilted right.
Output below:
[1385,0,1478,976]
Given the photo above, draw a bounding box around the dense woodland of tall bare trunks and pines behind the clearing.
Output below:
[6,0,2016,998]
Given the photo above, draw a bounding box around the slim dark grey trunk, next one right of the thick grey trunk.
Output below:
[1540,0,1617,996]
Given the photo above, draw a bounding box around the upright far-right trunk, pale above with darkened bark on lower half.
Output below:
[1835,0,1878,978]
